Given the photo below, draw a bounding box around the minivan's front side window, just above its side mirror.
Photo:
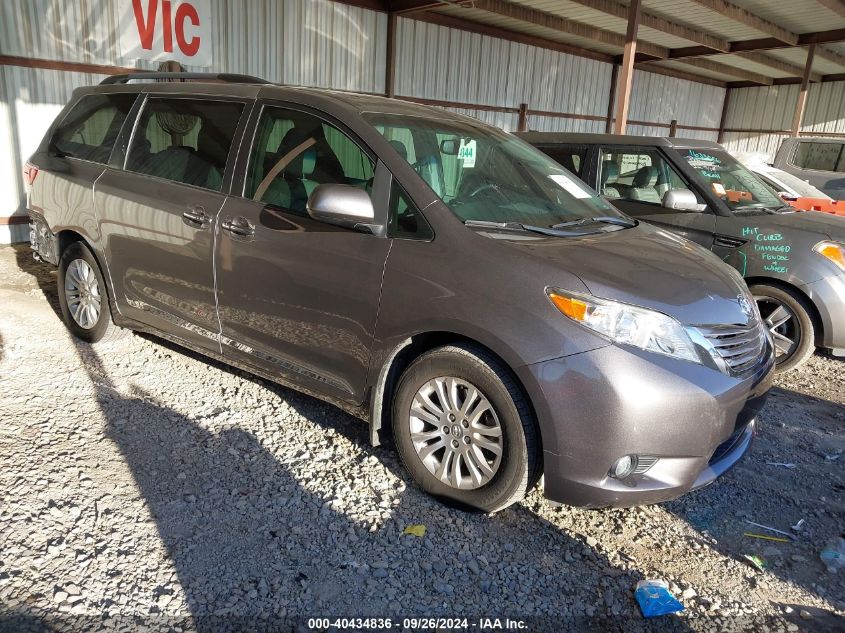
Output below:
[244,106,375,214]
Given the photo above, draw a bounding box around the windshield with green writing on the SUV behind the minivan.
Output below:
[678,149,784,211]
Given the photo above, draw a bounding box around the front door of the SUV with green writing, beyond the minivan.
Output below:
[596,146,716,248]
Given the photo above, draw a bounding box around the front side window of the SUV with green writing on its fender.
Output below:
[599,149,701,205]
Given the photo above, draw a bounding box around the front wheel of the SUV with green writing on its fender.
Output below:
[750,284,816,372]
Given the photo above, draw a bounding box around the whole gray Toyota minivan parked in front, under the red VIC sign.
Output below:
[26,74,773,512]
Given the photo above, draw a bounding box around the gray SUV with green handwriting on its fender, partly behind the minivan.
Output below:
[520,132,845,371]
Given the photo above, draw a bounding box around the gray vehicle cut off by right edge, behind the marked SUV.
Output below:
[772,136,845,200]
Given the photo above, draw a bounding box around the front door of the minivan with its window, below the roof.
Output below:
[215,102,391,403]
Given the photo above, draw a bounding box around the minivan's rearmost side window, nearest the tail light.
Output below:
[51,94,137,164]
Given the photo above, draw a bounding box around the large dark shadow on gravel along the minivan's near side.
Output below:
[67,344,685,631]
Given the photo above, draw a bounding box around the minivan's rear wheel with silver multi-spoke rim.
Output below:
[58,242,122,343]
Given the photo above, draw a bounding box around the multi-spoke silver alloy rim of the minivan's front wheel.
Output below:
[410,376,504,490]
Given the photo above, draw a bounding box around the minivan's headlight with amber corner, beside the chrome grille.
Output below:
[546,288,701,363]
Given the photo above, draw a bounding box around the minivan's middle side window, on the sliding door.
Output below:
[126,98,244,191]
